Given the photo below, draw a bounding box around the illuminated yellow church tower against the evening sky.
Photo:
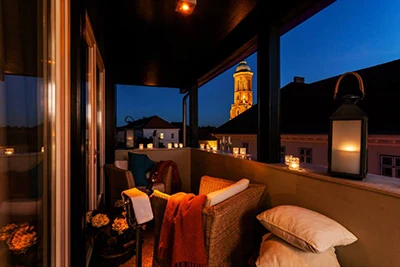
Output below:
[230,61,253,119]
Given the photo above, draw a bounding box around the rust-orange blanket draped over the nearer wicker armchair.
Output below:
[158,193,207,267]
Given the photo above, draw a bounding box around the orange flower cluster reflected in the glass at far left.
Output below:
[0,223,37,254]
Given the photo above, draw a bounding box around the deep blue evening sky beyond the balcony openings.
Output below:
[117,0,400,126]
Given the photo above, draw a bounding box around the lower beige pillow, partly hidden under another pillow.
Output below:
[256,233,340,267]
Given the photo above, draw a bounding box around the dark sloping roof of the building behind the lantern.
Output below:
[216,60,400,134]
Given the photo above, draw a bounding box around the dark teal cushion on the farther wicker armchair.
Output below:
[128,152,154,186]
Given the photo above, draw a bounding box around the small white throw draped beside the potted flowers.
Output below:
[121,188,154,224]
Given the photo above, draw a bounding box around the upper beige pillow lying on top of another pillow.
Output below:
[257,205,357,253]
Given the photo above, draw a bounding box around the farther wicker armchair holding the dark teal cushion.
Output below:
[105,164,172,207]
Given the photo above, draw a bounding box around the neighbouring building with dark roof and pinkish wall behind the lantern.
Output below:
[215,60,400,178]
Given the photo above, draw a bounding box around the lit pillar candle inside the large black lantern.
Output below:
[331,147,361,174]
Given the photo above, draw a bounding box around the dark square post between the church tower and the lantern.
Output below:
[257,1,281,163]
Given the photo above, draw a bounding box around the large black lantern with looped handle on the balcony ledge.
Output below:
[328,72,368,180]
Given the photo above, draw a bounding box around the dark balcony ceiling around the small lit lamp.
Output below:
[106,0,334,88]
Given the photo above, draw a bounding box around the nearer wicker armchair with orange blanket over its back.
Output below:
[151,176,265,267]
